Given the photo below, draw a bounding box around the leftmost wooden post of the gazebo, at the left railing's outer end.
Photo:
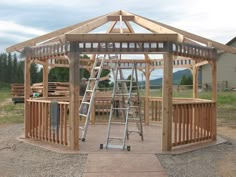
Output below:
[24,47,31,138]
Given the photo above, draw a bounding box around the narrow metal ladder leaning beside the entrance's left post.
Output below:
[79,54,106,141]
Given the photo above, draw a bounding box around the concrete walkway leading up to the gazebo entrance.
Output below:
[83,153,167,177]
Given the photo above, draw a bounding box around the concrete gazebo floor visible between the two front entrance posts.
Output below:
[80,124,162,154]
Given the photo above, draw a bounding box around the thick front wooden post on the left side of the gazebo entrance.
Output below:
[69,42,80,150]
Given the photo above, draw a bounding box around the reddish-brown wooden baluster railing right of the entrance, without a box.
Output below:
[172,100,216,146]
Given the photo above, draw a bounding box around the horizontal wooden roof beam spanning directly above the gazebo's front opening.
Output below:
[65,34,178,42]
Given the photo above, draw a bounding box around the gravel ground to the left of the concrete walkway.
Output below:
[0,124,87,177]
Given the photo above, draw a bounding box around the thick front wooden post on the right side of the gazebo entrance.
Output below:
[162,53,173,151]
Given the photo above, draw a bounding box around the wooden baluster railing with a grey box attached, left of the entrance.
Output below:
[27,100,69,146]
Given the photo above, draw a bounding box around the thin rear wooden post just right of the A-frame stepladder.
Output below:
[144,62,150,125]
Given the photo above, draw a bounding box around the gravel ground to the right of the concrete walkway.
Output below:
[157,134,236,177]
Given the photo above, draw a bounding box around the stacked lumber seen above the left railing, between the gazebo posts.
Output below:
[31,82,69,97]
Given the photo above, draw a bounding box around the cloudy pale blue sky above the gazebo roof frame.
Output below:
[0,0,236,52]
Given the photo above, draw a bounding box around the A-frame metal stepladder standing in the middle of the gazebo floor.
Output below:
[100,62,143,151]
